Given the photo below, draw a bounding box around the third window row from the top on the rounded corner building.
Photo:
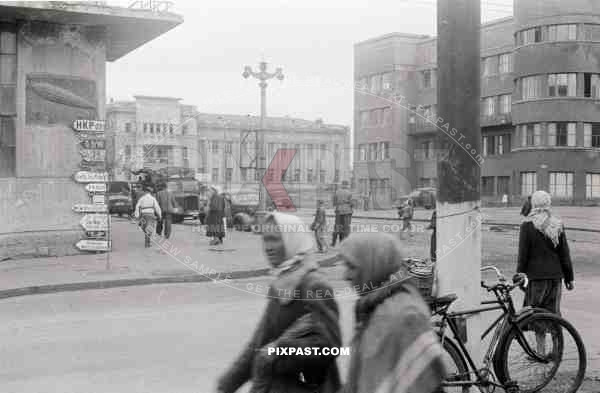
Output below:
[517,122,600,147]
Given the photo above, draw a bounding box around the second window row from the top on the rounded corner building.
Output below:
[517,72,600,100]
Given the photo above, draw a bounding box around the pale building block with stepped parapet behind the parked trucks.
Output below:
[106,96,200,180]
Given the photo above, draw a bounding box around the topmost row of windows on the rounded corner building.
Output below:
[515,23,600,46]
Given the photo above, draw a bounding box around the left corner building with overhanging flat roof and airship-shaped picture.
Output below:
[0,2,182,259]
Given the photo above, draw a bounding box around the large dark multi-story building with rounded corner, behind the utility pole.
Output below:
[354,0,600,206]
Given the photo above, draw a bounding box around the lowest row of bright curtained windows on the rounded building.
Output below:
[521,172,600,199]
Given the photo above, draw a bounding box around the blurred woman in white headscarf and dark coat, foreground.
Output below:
[217,213,341,393]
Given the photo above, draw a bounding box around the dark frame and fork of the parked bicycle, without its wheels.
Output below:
[434,282,545,392]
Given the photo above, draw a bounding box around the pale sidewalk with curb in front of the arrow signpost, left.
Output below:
[0,219,335,299]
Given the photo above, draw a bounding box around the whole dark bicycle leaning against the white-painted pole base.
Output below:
[430,266,586,393]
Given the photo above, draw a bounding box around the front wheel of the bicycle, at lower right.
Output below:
[494,313,586,393]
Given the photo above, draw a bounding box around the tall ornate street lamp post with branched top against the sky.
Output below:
[242,61,283,215]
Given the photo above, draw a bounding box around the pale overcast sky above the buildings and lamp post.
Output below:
[107,0,512,126]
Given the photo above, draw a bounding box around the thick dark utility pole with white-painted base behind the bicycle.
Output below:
[436,0,482,359]
